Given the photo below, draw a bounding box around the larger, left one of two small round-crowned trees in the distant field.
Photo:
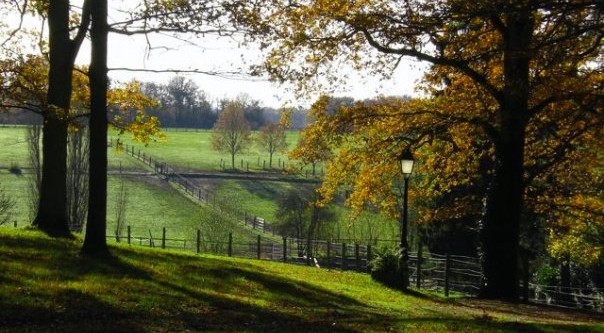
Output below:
[212,102,251,169]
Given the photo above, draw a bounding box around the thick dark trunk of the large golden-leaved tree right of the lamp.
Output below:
[481,11,534,301]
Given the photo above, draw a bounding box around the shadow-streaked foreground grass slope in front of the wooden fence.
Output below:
[0,229,604,333]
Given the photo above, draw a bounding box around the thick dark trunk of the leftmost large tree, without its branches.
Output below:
[33,0,73,236]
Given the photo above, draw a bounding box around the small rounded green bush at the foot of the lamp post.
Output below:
[369,248,403,289]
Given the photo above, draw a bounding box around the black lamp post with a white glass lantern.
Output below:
[400,148,415,290]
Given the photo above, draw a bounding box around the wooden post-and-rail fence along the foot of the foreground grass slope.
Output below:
[107,228,604,312]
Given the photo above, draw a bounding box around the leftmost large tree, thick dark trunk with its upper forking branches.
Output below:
[3,0,90,236]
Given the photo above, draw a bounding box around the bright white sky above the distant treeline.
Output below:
[3,0,426,108]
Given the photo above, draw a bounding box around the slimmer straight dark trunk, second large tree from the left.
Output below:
[82,0,109,257]
